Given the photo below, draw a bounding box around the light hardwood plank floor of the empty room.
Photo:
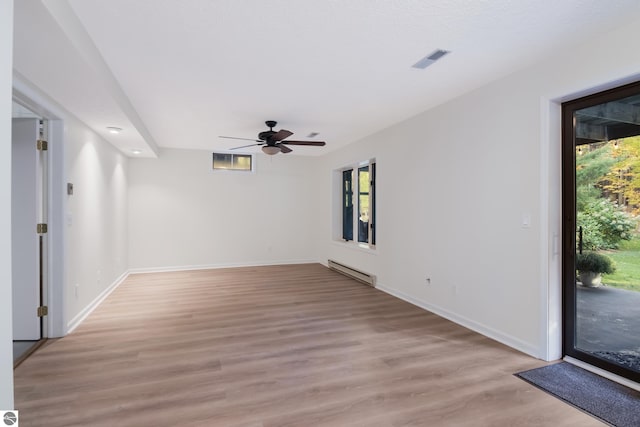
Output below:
[15,264,602,427]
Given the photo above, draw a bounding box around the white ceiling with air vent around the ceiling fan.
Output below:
[14,0,640,156]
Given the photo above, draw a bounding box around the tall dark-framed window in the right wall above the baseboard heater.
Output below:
[342,161,376,247]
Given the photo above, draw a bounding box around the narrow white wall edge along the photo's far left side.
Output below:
[0,0,13,410]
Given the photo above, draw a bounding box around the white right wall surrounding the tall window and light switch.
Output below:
[320,16,640,358]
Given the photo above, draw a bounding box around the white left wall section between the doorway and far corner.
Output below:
[64,116,128,328]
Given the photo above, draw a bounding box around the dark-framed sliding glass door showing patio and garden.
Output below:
[562,82,640,382]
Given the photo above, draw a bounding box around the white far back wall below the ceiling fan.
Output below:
[129,149,318,271]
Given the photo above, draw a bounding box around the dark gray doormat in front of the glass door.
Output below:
[515,362,640,427]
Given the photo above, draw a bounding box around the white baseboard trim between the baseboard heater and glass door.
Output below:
[376,283,542,359]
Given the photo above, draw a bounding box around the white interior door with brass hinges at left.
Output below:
[11,118,42,340]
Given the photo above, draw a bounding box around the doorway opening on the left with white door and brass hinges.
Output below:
[11,101,49,367]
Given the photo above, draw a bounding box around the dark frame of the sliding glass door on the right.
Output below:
[561,81,640,382]
